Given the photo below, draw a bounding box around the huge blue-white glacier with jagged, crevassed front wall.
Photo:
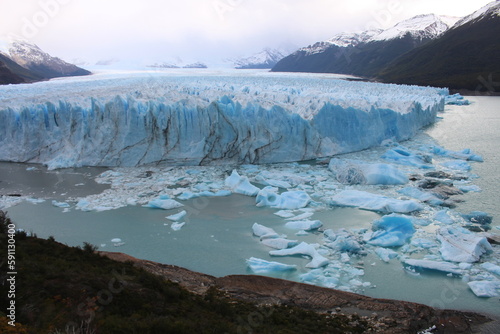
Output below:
[0,72,445,168]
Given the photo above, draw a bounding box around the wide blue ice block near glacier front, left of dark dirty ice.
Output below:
[328,158,408,185]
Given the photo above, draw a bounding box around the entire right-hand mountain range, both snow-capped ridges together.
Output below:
[272,1,500,90]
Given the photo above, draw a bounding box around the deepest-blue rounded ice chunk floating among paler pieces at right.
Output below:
[363,214,415,247]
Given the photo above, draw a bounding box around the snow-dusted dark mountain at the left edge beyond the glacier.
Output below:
[0,41,90,84]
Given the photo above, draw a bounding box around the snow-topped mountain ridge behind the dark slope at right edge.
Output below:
[272,14,459,76]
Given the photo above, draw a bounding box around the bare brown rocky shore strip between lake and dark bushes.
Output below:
[101,252,500,333]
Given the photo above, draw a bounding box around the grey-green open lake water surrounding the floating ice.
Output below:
[0,97,500,315]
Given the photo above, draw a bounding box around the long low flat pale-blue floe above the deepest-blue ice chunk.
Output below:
[330,190,423,213]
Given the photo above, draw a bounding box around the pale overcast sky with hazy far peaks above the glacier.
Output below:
[0,0,490,66]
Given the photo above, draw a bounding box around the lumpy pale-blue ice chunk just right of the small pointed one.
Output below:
[256,187,311,210]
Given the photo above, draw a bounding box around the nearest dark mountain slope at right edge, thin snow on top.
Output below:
[376,1,500,91]
